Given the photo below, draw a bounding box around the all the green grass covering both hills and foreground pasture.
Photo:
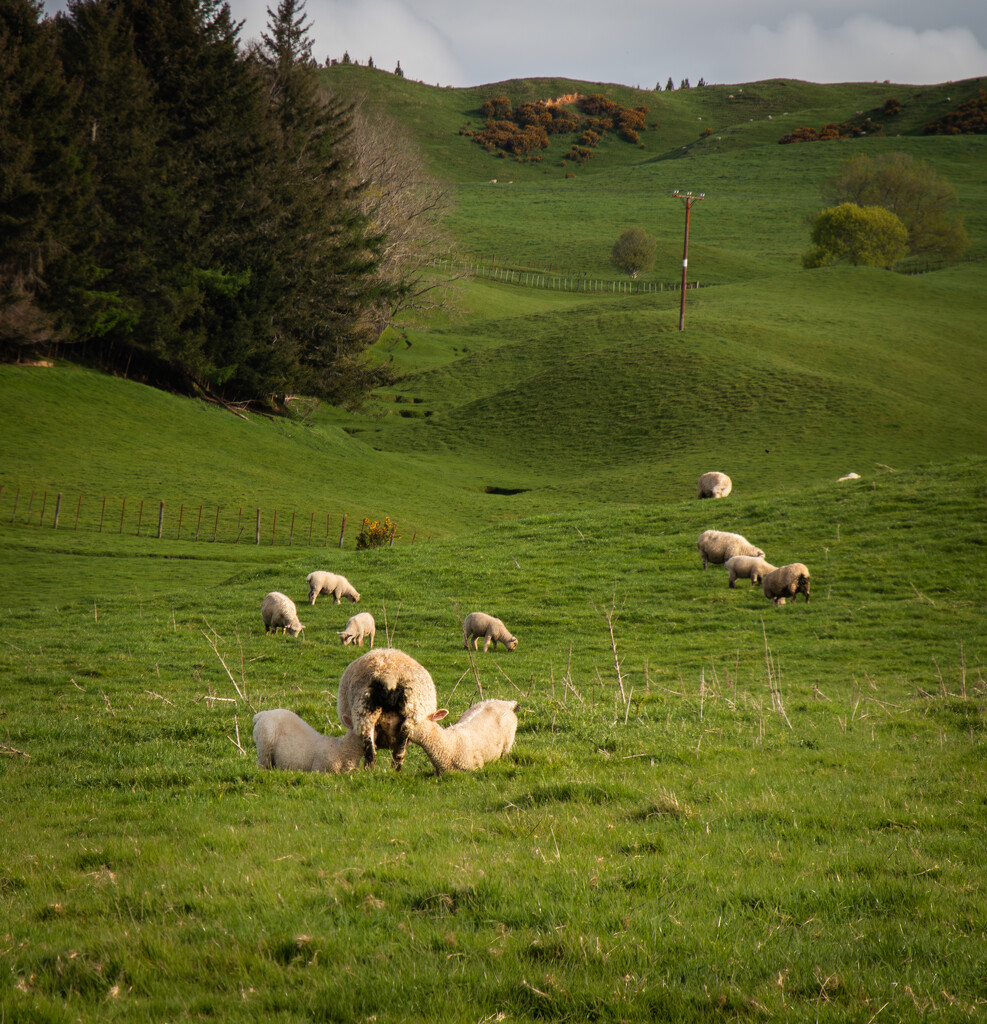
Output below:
[0,74,987,1022]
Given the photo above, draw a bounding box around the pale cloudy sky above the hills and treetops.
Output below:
[45,0,987,89]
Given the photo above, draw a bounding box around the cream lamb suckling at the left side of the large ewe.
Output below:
[254,708,401,774]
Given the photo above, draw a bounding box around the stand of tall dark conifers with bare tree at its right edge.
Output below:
[0,0,442,409]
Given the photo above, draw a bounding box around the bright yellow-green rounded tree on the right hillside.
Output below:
[802,203,908,270]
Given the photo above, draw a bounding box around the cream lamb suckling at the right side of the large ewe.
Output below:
[399,700,517,775]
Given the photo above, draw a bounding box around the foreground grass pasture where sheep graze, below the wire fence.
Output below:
[0,459,987,1022]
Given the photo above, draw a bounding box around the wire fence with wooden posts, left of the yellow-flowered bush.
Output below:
[0,484,418,548]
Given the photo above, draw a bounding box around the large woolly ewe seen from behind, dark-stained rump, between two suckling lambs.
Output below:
[336,647,438,771]
